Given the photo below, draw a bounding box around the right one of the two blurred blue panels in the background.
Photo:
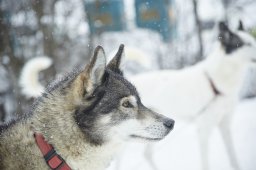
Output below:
[135,0,175,41]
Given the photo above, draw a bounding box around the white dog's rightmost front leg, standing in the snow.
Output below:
[219,114,240,170]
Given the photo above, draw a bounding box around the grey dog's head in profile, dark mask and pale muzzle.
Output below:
[72,45,174,144]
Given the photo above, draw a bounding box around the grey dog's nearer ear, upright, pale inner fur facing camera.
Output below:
[74,46,106,98]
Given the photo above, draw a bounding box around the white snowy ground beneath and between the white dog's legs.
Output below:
[108,99,256,170]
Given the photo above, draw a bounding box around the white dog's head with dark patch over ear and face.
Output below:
[219,21,256,62]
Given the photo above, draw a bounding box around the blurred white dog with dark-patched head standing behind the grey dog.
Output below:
[131,22,256,170]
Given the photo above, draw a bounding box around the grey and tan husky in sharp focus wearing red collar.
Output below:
[0,45,174,170]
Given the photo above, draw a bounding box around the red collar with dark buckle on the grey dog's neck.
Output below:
[34,133,71,170]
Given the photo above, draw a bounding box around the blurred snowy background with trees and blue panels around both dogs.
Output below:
[0,0,256,170]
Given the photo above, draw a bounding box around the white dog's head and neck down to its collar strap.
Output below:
[206,22,256,95]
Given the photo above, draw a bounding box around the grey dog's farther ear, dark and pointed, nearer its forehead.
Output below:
[107,44,124,74]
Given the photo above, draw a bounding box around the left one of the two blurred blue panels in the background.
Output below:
[84,0,125,34]
